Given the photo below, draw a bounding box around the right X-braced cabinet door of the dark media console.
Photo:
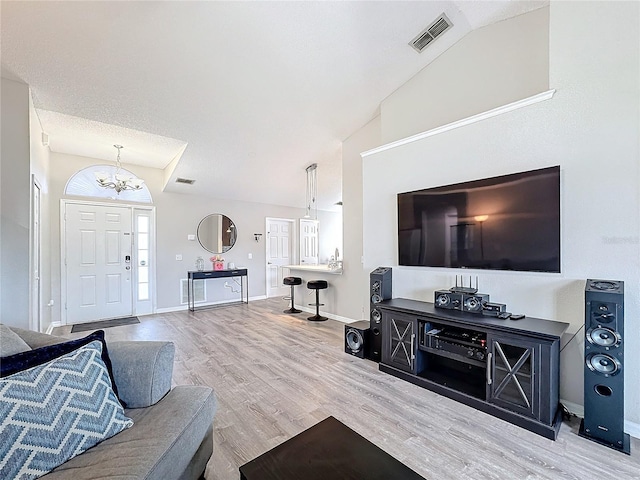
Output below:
[487,334,540,418]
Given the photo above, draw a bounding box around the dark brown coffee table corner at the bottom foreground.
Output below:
[240,417,425,480]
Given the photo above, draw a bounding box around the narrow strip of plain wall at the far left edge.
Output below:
[0,78,31,328]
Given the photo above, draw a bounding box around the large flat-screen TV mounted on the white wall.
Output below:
[398,166,560,272]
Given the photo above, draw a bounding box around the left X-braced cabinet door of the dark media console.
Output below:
[382,312,418,373]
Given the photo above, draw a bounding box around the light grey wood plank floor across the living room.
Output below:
[56,299,640,480]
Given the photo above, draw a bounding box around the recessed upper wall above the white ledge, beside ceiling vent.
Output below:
[380,8,549,143]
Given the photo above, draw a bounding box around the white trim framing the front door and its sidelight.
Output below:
[60,198,156,325]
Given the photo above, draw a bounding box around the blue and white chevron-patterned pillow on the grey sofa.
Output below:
[0,340,133,480]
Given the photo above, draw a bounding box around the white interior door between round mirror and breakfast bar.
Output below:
[267,218,293,298]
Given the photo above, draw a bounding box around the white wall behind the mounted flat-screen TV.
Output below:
[363,2,640,434]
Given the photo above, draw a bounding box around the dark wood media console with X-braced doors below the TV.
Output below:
[378,298,569,440]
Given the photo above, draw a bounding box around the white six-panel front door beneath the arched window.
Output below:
[63,203,133,324]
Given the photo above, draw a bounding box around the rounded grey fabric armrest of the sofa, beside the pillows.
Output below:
[107,341,175,408]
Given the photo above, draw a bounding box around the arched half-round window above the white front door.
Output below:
[64,165,153,203]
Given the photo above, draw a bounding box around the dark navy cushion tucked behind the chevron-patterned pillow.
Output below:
[0,330,127,407]
